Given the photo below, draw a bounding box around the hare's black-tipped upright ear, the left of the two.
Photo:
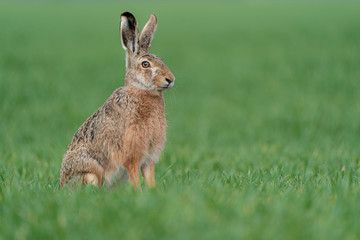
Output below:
[120,12,139,53]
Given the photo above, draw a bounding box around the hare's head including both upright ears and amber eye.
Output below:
[120,12,175,92]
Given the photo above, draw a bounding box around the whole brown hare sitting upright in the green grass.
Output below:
[60,12,175,188]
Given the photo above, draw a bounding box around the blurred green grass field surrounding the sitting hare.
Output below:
[0,1,360,240]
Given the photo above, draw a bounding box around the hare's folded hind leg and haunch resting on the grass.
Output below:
[60,152,104,188]
